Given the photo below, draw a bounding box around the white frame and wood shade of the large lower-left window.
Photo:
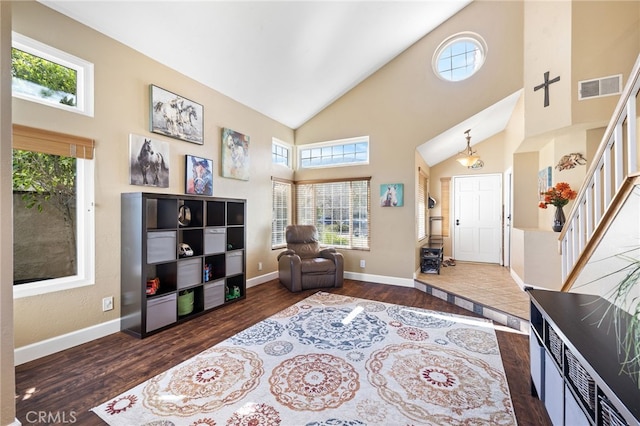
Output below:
[13,124,95,299]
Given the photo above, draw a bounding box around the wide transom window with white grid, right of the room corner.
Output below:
[298,137,369,169]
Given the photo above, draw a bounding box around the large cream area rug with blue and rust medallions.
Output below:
[92,292,516,426]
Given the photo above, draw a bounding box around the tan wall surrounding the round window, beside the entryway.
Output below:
[296,2,522,278]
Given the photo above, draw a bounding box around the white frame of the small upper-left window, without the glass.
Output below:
[11,31,94,117]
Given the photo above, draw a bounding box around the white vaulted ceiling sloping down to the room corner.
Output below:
[39,0,471,129]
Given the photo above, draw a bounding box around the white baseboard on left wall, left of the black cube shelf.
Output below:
[14,318,120,365]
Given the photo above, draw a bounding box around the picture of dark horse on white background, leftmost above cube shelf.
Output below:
[129,134,169,188]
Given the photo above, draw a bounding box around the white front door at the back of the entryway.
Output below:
[453,175,502,264]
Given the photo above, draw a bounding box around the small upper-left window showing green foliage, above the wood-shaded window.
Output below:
[11,32,93,117]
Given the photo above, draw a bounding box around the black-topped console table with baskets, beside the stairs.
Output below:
[529,290,640,426]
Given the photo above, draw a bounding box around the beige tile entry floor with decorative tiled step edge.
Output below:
[416,261,529,332]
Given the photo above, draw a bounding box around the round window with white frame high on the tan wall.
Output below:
[433,33,487,81]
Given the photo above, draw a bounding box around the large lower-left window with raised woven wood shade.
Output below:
[13,125,95,298]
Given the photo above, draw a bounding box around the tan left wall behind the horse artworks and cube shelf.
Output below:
[13,2,293,347]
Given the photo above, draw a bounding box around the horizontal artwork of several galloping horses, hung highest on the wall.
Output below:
[149,84,204,145]
